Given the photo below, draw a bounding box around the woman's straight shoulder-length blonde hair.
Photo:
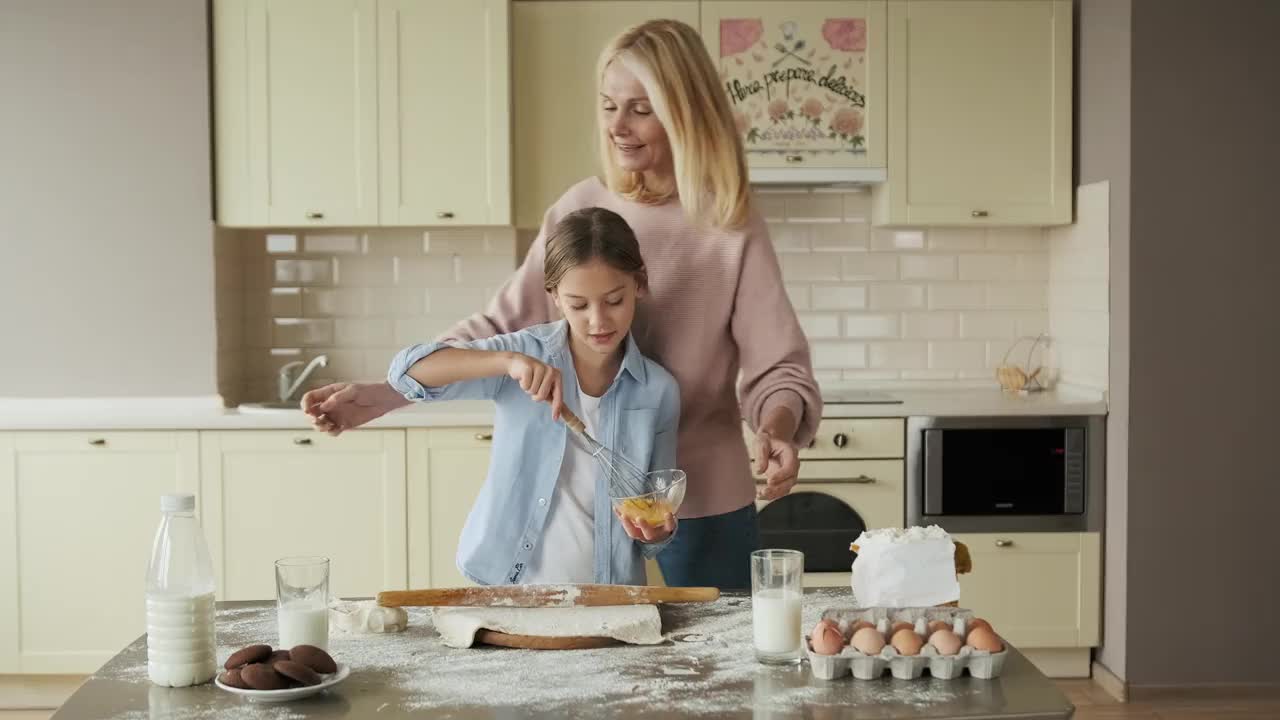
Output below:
[596,20,750,228]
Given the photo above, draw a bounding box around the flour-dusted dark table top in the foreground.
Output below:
[62,589,1074,720]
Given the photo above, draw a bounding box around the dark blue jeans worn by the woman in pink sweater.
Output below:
[658,502,760,589]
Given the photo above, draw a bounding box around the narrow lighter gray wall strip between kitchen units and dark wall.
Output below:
[1075,0,1132,678]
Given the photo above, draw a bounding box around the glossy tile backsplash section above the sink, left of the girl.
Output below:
[230,228,514,400]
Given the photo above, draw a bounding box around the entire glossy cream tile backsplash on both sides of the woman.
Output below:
[219,188,1107,388]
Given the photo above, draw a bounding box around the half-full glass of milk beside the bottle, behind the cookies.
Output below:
[275,557,329,650]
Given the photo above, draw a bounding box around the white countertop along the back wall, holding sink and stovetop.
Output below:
[0,386,1107,430]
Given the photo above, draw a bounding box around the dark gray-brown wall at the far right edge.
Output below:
[1125,0,1280,688]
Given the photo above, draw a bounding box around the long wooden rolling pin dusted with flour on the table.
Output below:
[378,584,719,607]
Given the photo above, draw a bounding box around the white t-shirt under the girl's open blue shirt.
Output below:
[520,388,602,584]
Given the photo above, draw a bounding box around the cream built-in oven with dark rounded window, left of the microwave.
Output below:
[746,418,905,587]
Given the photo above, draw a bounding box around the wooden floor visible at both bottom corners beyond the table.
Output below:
[0,678,1280,720]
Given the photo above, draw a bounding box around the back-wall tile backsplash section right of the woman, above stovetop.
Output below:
[756,190,1051,386]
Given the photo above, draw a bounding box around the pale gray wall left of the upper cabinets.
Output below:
[0,0,216,397]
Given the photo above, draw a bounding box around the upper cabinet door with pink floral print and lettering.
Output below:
[700,0,887,182]
